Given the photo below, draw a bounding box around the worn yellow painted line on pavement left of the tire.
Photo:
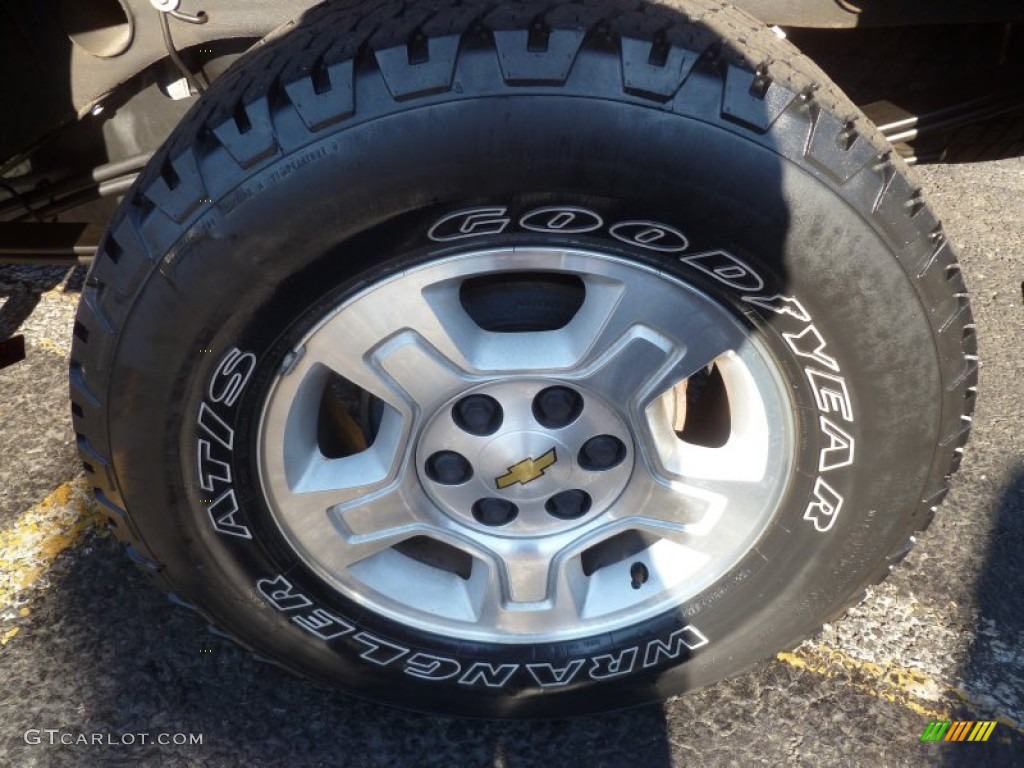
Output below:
[0,475,102,626]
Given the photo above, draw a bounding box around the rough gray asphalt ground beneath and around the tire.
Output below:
[0,154,1024,768]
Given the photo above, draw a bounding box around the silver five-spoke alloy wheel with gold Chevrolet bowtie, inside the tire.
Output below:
[258,247,796,642]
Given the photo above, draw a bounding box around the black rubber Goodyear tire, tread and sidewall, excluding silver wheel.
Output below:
[71,0,977,717]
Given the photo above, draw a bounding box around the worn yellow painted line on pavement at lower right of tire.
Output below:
[776,643,1024,734]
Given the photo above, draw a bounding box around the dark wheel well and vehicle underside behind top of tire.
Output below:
[0,0,1024,243]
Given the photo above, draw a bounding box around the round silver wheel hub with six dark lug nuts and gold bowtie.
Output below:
[416,379,633,537]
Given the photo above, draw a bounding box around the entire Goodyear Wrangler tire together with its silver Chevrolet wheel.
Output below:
[71,0,977,717]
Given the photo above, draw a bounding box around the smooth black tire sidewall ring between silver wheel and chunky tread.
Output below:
[105,97,936,715]
